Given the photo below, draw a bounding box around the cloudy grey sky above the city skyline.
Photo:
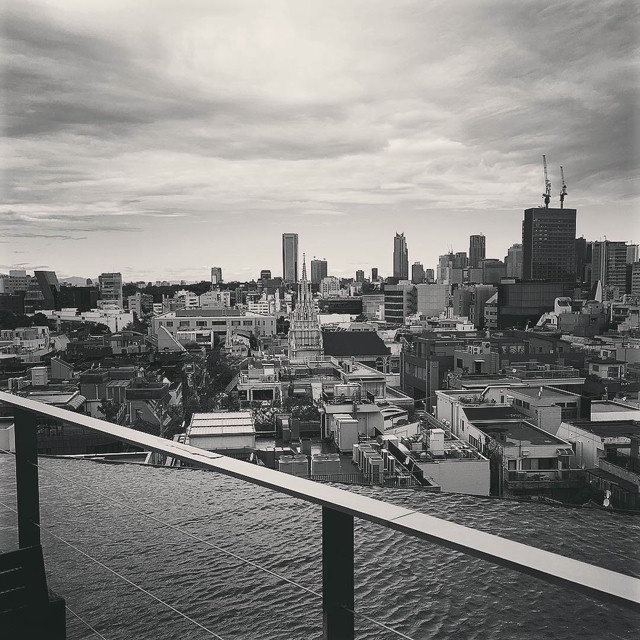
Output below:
[0,0,640,280]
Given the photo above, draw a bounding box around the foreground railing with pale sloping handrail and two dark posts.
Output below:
[0,392,640,640]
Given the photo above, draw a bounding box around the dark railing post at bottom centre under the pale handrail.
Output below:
[322,507,355,640]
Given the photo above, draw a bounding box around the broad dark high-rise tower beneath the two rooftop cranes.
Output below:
[522,207,576,282]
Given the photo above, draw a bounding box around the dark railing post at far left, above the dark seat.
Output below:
[13,409,40,549]
